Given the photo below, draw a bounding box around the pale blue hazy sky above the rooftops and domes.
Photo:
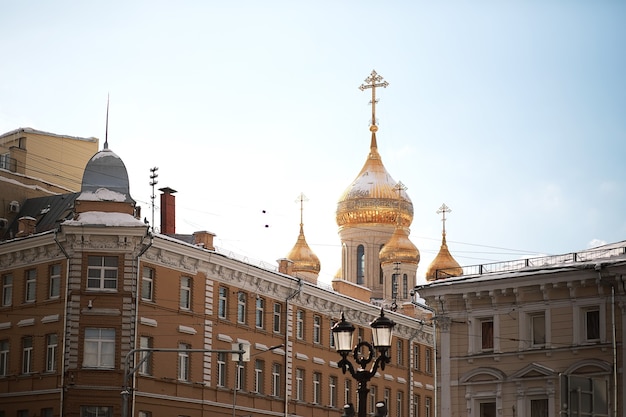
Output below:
[0,0,626,283]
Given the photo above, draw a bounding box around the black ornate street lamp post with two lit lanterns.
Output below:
[332,308,396,417]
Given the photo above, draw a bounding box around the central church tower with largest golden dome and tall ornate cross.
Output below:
[336,71,419,304]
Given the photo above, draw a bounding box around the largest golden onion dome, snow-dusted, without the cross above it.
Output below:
[336,130,413,228]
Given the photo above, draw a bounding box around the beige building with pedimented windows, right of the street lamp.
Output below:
[416,242,626,417]
